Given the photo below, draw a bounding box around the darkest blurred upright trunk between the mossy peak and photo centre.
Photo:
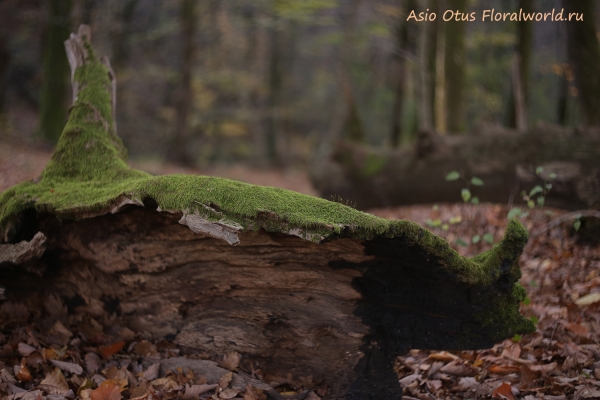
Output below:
[168,0,197,166]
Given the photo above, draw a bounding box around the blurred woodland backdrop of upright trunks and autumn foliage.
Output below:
[0,0,600,167]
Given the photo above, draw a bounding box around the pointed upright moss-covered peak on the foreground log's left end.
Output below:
[41,37,145,184]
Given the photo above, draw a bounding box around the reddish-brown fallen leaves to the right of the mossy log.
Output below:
[371,204,600,400]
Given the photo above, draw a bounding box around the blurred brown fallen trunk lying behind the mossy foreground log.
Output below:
[311,126,600,209]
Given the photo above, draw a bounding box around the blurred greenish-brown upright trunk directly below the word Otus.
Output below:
[444,0,467,133]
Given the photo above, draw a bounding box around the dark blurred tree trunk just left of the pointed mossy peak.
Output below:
[39,0,71,143]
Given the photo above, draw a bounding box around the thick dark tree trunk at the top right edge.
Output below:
[563,0,600,126]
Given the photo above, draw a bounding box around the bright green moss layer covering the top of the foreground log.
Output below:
[0,38,530,338]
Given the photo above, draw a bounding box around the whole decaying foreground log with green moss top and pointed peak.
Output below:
[0,28,533,399]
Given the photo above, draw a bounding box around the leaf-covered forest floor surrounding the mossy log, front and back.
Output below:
[0,143,600,400]
